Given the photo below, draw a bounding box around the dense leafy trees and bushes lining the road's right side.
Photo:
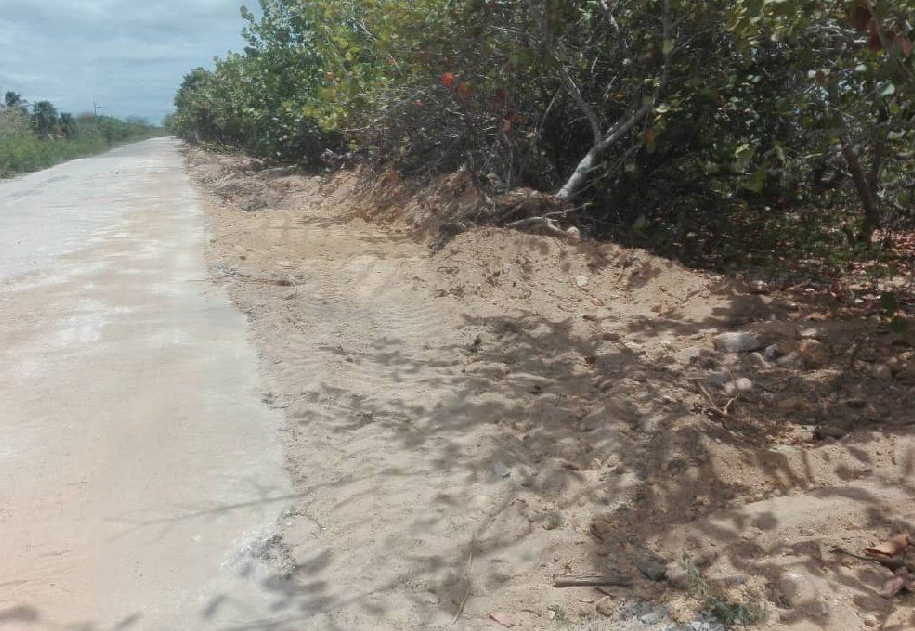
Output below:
[170,0,915,262]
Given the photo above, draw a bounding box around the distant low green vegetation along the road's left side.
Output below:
[0,92,161,177]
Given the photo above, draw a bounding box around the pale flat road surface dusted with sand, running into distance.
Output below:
[0,139,291,630]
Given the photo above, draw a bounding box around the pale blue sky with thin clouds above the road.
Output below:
[0,0,257,122]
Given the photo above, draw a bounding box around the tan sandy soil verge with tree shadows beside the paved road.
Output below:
[189,152,915,631]
